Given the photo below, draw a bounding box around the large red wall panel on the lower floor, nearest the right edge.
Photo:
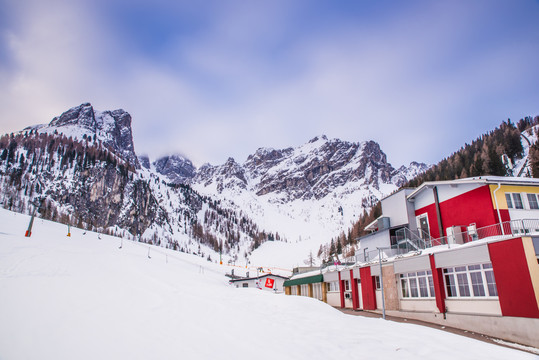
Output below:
[488,238,539,318]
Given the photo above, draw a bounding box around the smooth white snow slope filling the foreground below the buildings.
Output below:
[0,209,538,360]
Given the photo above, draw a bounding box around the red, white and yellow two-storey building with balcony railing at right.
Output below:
[284,177,539,347]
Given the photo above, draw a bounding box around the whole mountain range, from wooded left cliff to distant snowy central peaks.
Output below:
[0,104,427,266]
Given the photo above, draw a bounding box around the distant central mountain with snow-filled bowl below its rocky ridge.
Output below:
[153,135,428,263]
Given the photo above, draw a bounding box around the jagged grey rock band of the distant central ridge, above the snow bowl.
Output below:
[188,136,428,202]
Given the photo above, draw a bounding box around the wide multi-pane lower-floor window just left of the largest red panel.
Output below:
[444,264,498,297]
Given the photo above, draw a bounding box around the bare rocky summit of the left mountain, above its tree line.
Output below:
[38,103,140,169]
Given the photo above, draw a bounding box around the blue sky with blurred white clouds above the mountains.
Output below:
[0,0,539,166]
